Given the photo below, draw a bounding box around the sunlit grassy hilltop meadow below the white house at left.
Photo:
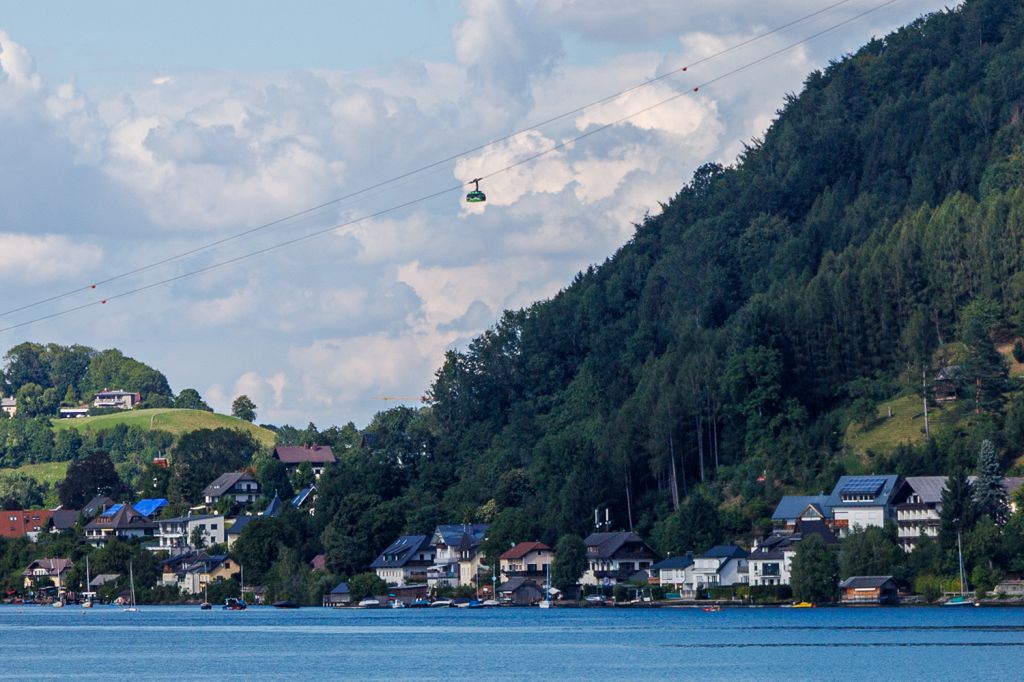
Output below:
[52,408,274,447]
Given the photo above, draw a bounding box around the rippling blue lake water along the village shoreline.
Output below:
[0,606,1024,682]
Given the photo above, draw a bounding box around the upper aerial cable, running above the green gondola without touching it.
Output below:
[0,0,864,319]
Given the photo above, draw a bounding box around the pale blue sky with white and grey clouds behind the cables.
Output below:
[0,0,954,426]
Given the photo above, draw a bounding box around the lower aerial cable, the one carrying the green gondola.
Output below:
[0,0,899,334]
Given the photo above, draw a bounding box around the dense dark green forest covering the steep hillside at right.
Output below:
[6,0,1024,598]
